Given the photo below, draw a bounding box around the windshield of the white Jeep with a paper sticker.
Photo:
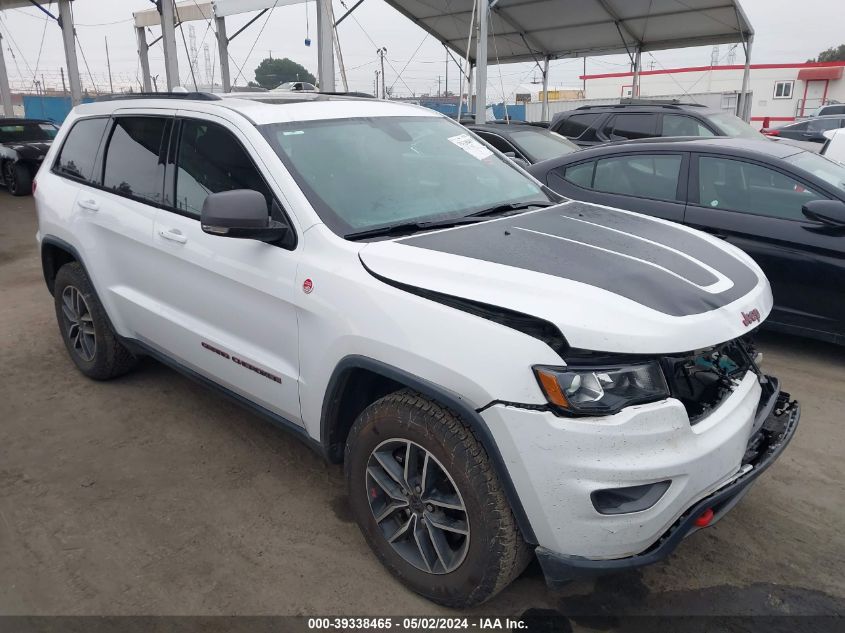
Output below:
[260,116,551,235]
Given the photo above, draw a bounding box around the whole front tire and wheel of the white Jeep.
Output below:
[345,390,532,608]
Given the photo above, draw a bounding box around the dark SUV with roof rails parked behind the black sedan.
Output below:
[549,99,761,147]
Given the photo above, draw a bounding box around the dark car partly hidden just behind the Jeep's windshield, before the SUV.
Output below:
[465,121,580,165]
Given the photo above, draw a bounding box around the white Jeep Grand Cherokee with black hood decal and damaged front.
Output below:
[35,94,799,606]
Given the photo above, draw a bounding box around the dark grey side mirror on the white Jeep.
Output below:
[200,189,289,242]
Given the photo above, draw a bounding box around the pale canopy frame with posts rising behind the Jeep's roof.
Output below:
[133,0,335,92]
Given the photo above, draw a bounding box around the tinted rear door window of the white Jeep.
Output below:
[103,117,172,204]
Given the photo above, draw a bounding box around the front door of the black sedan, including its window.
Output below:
[686,155,845,332]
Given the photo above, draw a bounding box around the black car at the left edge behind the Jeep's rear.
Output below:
[0,119,59,196]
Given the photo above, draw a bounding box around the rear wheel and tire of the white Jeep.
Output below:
[53,262,137,380]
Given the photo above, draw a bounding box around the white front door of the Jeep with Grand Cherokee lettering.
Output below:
[148,113,302,423]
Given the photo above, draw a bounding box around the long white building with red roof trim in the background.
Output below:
[580,61,845,123]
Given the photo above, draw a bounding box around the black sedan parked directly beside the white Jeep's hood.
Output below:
[528,137,845,344]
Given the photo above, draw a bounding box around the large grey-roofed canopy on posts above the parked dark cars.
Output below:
[385,0,754,121]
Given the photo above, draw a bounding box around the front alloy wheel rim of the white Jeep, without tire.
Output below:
[366,438,470,574]
